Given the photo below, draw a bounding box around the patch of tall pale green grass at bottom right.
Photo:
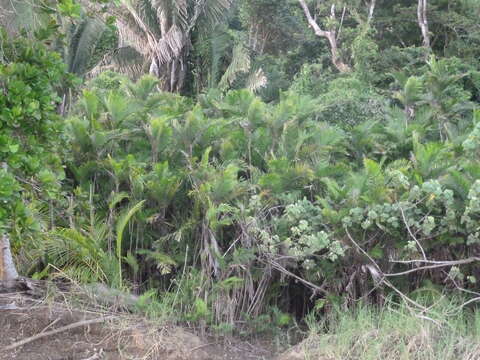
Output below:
[296,301,480,360]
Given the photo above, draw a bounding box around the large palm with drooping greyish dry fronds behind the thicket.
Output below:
[96,0,234,92]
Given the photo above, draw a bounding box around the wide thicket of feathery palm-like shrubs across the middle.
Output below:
[39,56,479,324]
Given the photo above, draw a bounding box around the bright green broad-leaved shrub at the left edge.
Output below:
[0,32,71,255]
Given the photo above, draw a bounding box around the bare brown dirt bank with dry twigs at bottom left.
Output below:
[0,293,284,360]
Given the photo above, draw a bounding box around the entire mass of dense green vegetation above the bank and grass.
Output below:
[0,0,480,340]
